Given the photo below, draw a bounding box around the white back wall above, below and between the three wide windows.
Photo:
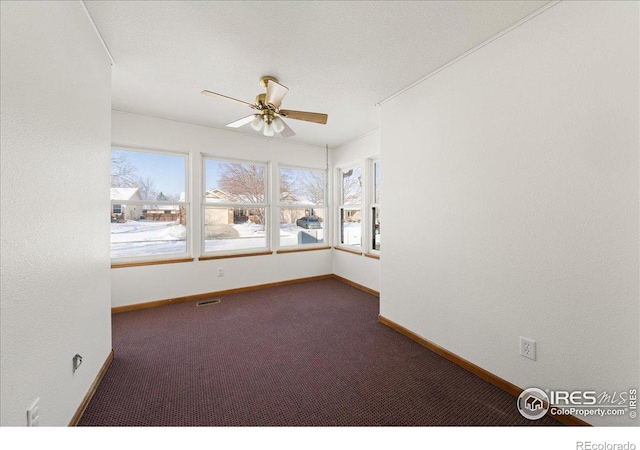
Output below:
[111,112,331,307]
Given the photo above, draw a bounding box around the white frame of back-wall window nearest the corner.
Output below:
[274,163,331,252]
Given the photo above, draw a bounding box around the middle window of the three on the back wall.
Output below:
[202,158,269,253]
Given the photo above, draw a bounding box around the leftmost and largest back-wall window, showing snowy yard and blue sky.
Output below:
[111,148,189,261]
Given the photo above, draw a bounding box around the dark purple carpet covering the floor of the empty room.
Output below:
[79,279,559,426]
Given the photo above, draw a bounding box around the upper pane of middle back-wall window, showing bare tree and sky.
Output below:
[205,160,266,203]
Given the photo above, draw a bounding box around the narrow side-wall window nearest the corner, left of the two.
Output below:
[339,167,362,247]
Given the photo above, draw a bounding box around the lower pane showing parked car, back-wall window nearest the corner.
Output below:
[280,208,326,247]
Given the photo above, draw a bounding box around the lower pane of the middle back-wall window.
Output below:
[204,206,267,252]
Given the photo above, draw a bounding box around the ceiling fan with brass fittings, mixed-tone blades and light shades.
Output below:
[202,76,329,138]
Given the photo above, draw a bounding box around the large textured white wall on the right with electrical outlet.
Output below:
[381,2,640,425]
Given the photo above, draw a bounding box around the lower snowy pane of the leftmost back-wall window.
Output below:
[111,204,187,258]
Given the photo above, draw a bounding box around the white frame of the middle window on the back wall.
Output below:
[199,153,273,260]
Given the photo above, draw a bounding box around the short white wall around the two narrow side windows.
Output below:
[331,130,386,292]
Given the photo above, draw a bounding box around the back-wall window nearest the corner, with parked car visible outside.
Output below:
[279,167,326,247]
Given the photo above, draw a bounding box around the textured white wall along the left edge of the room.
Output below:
[0,2,111,427]
